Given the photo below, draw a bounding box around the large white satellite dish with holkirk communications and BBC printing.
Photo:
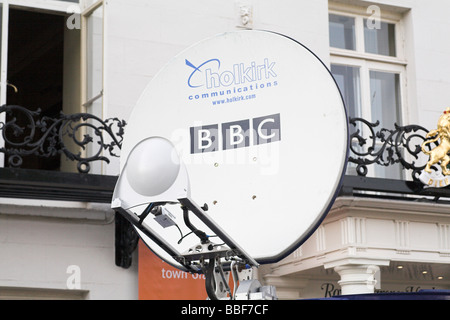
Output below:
[112,30,349,300]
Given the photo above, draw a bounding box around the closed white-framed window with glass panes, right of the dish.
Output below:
[329,6,407,178]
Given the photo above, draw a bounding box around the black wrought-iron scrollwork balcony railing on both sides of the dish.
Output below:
[0,105,438,180]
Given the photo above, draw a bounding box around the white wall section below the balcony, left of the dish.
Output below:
[0,199,138,299]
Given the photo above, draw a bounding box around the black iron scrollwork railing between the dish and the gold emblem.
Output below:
[348,118,436,180]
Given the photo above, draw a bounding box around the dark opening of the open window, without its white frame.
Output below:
[6,8,67,170]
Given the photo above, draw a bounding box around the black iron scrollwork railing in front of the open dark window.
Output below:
[0,105,126,173]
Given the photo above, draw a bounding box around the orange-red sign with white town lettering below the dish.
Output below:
[139,241,208,300]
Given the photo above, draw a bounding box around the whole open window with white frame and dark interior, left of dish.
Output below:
[0,0,103,171]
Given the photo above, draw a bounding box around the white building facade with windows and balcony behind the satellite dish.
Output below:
[0,0,450,299]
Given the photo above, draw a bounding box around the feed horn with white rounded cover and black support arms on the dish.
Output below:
[112,137,270,299]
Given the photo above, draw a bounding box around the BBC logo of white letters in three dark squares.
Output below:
[190,113,281,154]
